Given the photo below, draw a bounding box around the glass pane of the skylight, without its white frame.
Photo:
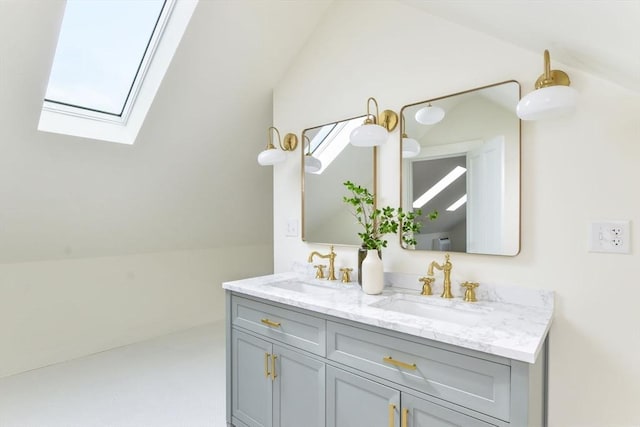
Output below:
[45,0,165,116]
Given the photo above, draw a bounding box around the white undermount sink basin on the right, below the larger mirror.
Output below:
[370,294,492,326]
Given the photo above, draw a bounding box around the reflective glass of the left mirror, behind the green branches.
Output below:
[302,116,375,245]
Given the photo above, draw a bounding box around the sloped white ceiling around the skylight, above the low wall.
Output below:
[0,0,330,263]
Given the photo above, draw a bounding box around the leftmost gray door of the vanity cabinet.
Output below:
[231,329,273,427]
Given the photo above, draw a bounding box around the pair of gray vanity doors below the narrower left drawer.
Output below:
[231,330,325,427]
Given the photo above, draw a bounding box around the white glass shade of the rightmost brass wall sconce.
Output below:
[516,86,578,120]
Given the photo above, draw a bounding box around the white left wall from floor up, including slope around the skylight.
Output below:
[0,0,296,377]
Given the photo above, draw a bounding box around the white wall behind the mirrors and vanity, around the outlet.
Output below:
[274,1,640,427]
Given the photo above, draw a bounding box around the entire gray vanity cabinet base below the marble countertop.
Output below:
[227,292,546,427]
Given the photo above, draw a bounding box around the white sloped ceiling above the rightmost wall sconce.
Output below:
[399,0,640,93]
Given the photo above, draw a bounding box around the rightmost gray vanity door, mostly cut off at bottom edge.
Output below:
[400,393,494,427]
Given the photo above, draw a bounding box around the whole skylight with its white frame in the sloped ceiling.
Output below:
[38,0,198,144]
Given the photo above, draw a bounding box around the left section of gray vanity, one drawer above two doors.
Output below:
[227,297,326,427]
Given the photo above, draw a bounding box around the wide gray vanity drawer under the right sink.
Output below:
[327,322,511,421]
